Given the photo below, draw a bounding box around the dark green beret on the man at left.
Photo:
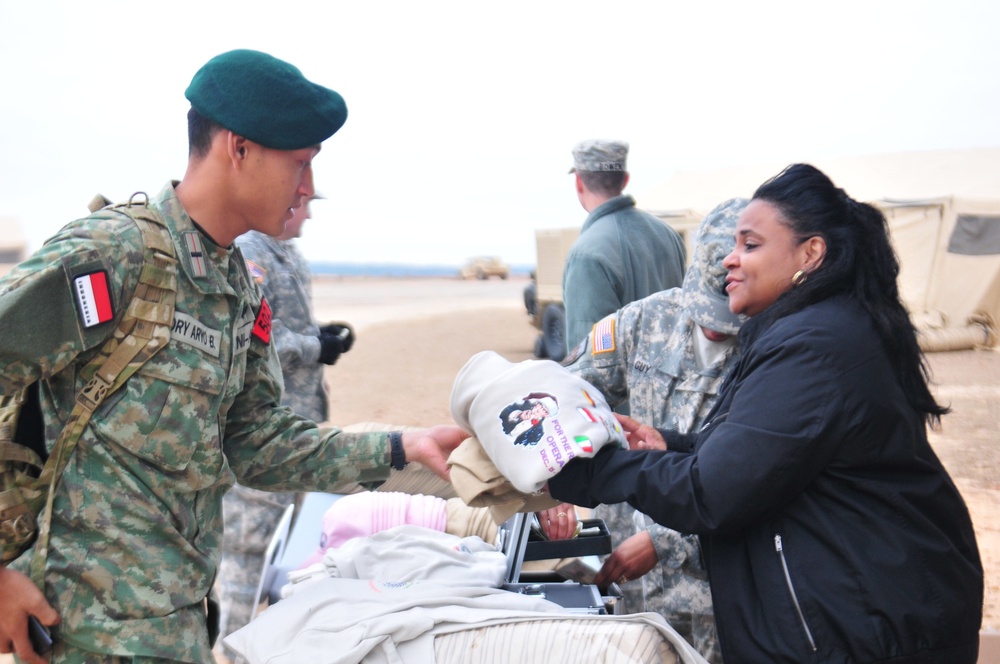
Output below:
[184,49,347,150]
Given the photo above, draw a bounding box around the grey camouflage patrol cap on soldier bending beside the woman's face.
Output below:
[683,198,750,334]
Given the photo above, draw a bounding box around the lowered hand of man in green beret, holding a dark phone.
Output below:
[0,567,59,664]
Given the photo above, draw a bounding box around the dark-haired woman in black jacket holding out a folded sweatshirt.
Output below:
[549,164,983,664]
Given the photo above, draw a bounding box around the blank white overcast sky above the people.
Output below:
[0,0,1000,264]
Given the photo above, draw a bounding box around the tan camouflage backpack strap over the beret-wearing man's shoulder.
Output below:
[31,192,177,590]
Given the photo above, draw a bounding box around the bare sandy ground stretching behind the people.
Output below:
[314,279,1000,632]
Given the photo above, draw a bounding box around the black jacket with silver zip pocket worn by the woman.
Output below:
[549,298,983,664]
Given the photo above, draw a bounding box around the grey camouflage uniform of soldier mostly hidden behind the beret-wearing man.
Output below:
[215,231,329,659]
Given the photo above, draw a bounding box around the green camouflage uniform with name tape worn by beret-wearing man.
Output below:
[0,185,390,662]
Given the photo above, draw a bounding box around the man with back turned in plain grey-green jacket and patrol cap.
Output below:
[564,140,686,361]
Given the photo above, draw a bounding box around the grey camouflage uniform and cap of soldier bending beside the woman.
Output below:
[568,199,747,662]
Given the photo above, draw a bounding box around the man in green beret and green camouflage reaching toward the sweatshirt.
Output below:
[0,50,466,663]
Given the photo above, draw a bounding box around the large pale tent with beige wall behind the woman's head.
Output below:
[636,148,1000,350]
